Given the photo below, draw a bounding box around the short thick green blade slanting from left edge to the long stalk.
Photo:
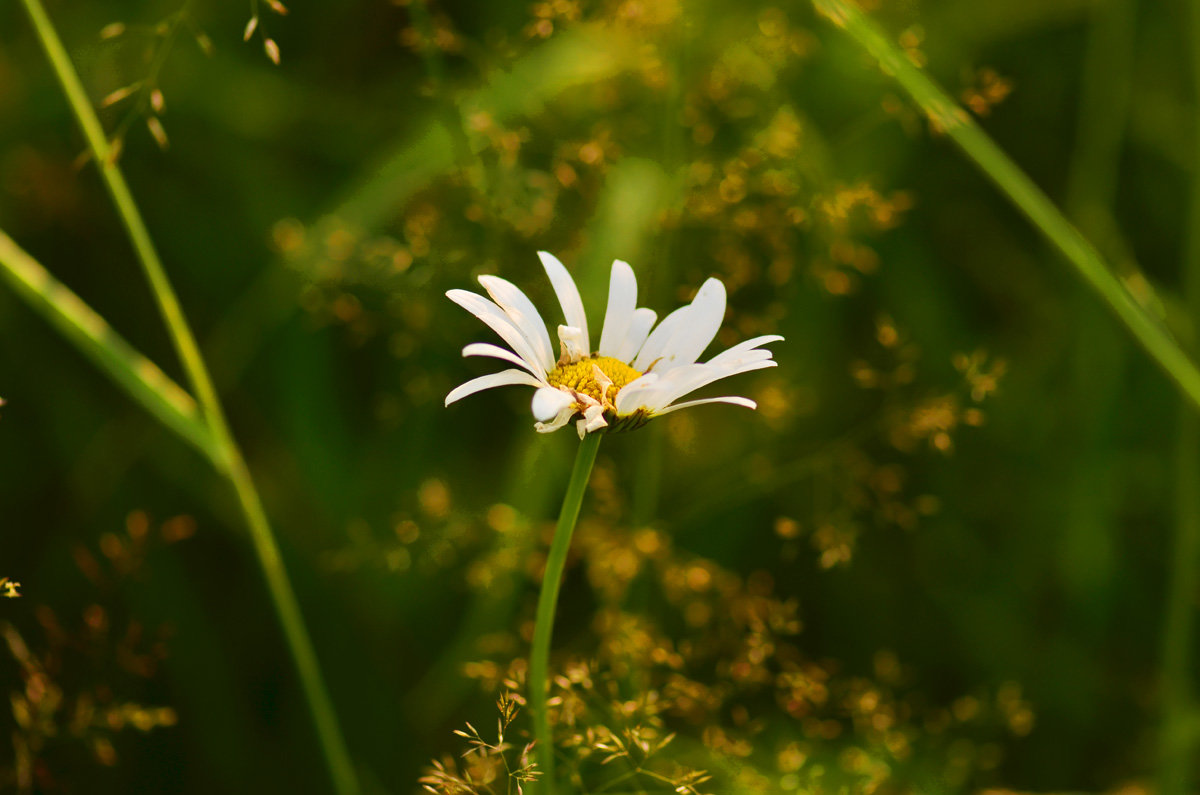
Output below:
[0,231,217,462]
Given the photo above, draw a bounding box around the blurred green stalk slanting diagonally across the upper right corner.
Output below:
[812,0,1200,410]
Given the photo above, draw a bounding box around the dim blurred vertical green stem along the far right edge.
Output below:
[1158,0,1200,795]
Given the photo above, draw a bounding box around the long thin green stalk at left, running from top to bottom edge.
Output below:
[22,0,359,795]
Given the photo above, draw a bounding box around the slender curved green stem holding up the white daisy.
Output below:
[528,434,600,795]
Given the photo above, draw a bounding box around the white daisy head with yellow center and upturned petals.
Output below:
[446,251,784,438]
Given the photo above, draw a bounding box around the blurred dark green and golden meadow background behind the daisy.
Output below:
[0,0,1200,793]
